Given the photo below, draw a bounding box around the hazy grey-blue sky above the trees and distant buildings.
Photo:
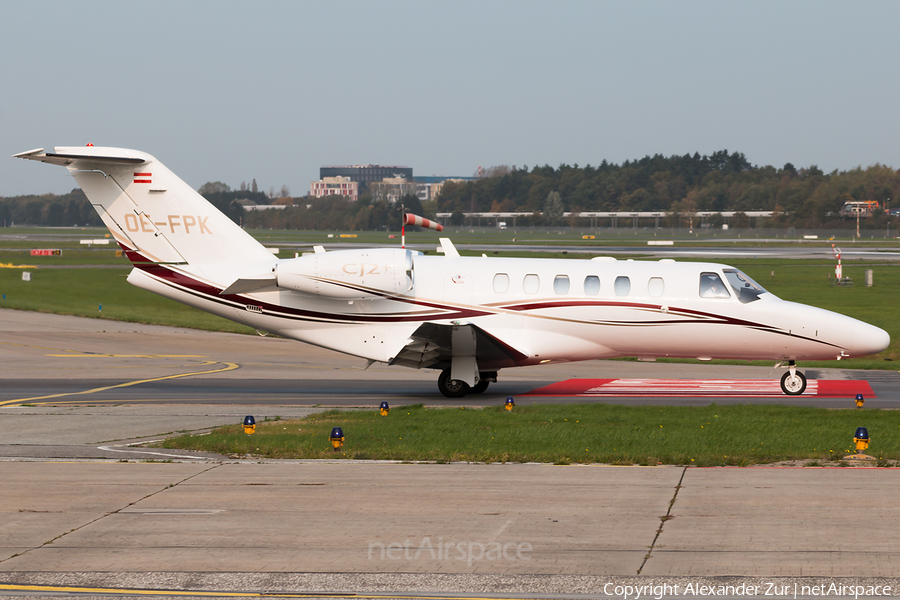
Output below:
[0,0,900,196]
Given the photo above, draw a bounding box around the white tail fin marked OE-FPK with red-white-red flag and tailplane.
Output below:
[14,146,272,264]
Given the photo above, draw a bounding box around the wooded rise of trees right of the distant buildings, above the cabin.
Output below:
[437,150,900,229]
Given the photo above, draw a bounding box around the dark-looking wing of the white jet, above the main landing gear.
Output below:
[389,323,528,371]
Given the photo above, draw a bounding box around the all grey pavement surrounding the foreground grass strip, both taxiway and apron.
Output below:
[0,310,900,598]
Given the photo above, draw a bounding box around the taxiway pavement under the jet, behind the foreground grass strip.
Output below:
[0,310,900,408]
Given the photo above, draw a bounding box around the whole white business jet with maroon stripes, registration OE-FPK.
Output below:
[15,146,890,398]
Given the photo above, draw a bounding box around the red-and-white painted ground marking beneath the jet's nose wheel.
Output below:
[523,379,876,399]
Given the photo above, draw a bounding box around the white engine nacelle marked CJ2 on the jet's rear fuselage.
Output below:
[275,248,418,300]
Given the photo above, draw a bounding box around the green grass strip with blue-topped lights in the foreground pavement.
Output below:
[160,400,900,466]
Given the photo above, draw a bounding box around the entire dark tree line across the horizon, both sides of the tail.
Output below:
[7,150,900,230]
